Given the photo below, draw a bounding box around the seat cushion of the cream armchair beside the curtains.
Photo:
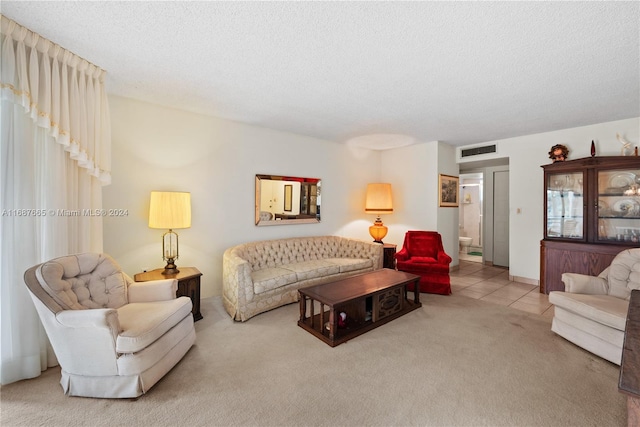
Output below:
[116,297,192,353]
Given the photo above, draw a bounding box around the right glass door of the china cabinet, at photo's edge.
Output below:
[597,169,640,243]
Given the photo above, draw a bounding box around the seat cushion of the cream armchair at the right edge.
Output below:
[549,291,629,331]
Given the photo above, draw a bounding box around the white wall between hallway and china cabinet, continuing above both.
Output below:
[461,118,640,281]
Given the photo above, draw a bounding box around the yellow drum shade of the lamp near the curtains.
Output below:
[149,191,191,229]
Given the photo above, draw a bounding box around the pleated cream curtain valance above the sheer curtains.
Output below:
[0,15,111,185]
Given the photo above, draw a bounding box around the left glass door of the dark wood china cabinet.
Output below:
[546,172,585,240]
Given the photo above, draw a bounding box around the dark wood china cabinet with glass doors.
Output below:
[540,156,640,294]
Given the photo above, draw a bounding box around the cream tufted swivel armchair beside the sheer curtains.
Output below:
[24,253,196,398]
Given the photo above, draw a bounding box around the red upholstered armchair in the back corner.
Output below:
[396,231,451,295]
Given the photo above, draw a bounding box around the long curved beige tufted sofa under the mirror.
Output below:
[222,236,384,322]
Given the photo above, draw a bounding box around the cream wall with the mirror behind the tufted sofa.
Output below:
[103,97,380,298]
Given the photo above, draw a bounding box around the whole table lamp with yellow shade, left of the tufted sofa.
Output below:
[149,191,191,274]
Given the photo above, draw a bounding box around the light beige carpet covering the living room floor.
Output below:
[0,294,626,426]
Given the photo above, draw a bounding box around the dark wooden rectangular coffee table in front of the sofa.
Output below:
[298,268,422,347]
